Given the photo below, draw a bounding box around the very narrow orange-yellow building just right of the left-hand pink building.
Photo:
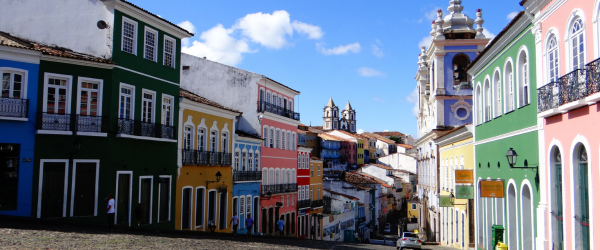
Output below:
[310,156,324,240]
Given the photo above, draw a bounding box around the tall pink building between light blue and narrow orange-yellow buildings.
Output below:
[257,78,300,237]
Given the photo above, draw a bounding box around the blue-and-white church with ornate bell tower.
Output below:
[415,0,490,242]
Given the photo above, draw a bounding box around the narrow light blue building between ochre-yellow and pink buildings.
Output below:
[232,130,263,234]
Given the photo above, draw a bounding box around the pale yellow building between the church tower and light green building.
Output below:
[435,125,475,249]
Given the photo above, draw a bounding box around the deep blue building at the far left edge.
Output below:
[0,35,41,216]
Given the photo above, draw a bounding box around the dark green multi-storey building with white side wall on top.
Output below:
[1,0,193,229]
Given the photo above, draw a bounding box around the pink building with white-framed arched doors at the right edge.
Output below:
[521,0,600,247]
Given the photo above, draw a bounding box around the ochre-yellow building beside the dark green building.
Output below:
[175,89,241,233]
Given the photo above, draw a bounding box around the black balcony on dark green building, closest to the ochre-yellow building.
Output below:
[117,118,175,141]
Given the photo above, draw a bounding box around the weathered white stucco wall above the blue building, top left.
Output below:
[0,0,113,57]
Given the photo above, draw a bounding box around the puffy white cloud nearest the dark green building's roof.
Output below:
[181,24,255,66]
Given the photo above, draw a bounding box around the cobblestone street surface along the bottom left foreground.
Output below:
[0,222,451,250]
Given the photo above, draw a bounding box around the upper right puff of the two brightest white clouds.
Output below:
[233,10,294,49]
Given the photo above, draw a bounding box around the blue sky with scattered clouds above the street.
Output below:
[130,0,523,136]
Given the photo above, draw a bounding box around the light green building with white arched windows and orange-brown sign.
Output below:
[467,12,543,250]
